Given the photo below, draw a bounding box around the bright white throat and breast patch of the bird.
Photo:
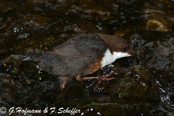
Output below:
[101,48,131,67]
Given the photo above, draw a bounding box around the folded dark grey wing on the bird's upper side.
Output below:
[46,34,107,57]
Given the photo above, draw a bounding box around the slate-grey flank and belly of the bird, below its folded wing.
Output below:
[32,53,98,77]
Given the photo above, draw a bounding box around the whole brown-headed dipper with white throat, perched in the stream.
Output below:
[30,34,134,89]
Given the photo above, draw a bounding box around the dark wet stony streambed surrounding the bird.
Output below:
[0,0,174,116]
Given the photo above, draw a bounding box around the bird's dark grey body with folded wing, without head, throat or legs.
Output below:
[31,34,108,77]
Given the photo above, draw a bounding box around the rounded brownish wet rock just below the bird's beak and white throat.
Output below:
[107,65,160,100]
